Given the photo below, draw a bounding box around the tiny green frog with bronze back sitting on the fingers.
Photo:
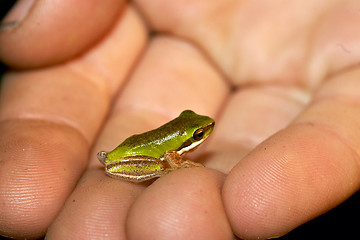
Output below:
[97,110,215,182]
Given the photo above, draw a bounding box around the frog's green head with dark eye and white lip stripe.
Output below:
[177,110,215,155]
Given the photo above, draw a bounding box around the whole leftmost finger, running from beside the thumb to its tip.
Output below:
[0,5,146,238]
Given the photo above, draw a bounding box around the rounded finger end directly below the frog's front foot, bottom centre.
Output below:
[127,168,232,239]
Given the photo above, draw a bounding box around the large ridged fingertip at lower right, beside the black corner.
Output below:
[223,125,359,239]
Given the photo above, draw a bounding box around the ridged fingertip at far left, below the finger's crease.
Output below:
[0,121,88,238]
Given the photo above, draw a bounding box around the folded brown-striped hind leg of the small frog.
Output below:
[106,156,168,182]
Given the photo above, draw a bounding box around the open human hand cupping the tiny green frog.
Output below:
[0,0,360,239]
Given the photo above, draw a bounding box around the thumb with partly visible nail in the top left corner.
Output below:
[0,0,124,68]
